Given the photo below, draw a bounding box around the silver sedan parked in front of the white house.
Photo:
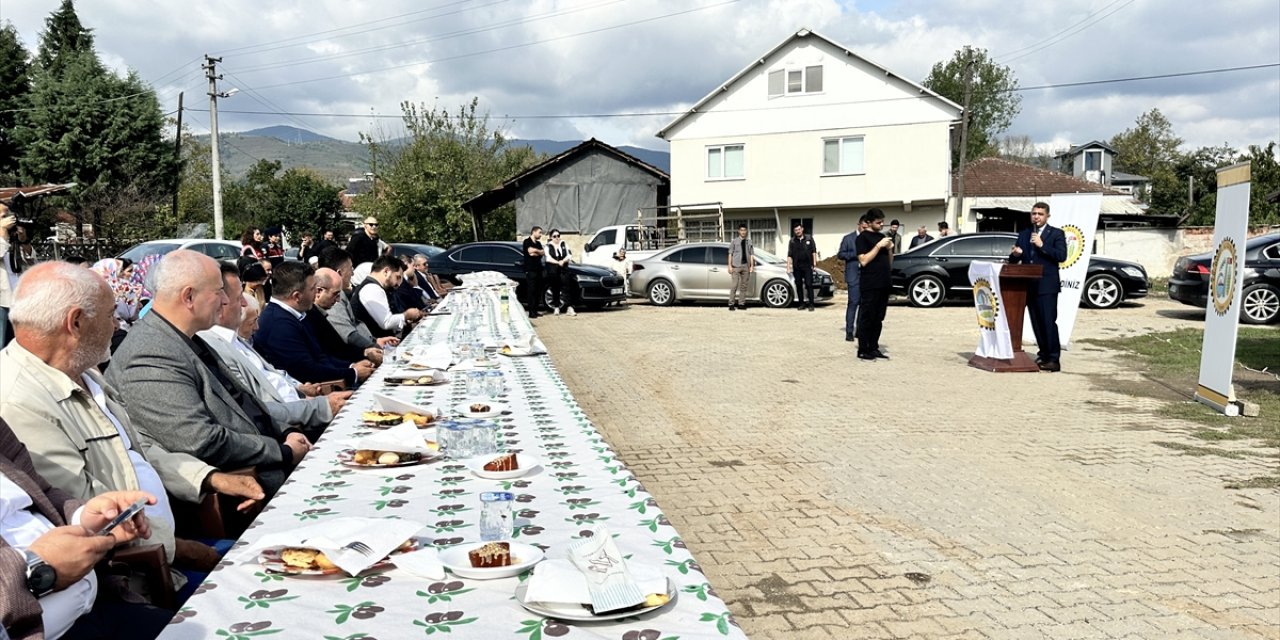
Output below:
[628,242,835,308]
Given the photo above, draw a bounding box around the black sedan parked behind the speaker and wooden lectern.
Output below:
[891,232,1149,308]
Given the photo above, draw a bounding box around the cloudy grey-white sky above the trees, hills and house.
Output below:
[0,0,1280,150]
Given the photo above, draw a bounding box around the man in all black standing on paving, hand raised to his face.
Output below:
[855,209,893,360]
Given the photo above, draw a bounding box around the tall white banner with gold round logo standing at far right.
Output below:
[1196,163,1251,416]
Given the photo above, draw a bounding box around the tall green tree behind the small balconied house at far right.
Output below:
[1111,109,1187,214]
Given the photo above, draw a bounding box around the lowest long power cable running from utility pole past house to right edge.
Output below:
[187,63,1280,120]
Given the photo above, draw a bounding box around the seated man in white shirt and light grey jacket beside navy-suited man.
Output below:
[197,264,351,435]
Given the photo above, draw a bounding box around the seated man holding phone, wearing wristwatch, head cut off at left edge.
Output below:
[0,419,173,640]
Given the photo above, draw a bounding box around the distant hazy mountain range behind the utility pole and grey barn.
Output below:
[197,125,671,186]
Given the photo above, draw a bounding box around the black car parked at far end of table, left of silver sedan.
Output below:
[428,242,627,308]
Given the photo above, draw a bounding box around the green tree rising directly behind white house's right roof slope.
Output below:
[923,49,1023,166]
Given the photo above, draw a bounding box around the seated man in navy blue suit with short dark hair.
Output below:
[253,262,374,388]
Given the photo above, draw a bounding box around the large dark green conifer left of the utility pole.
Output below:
[14,0,177,233]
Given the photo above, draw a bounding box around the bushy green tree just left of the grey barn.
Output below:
[356,99,539,247]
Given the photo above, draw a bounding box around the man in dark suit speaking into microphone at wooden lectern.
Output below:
[1009,202,1066,371]
